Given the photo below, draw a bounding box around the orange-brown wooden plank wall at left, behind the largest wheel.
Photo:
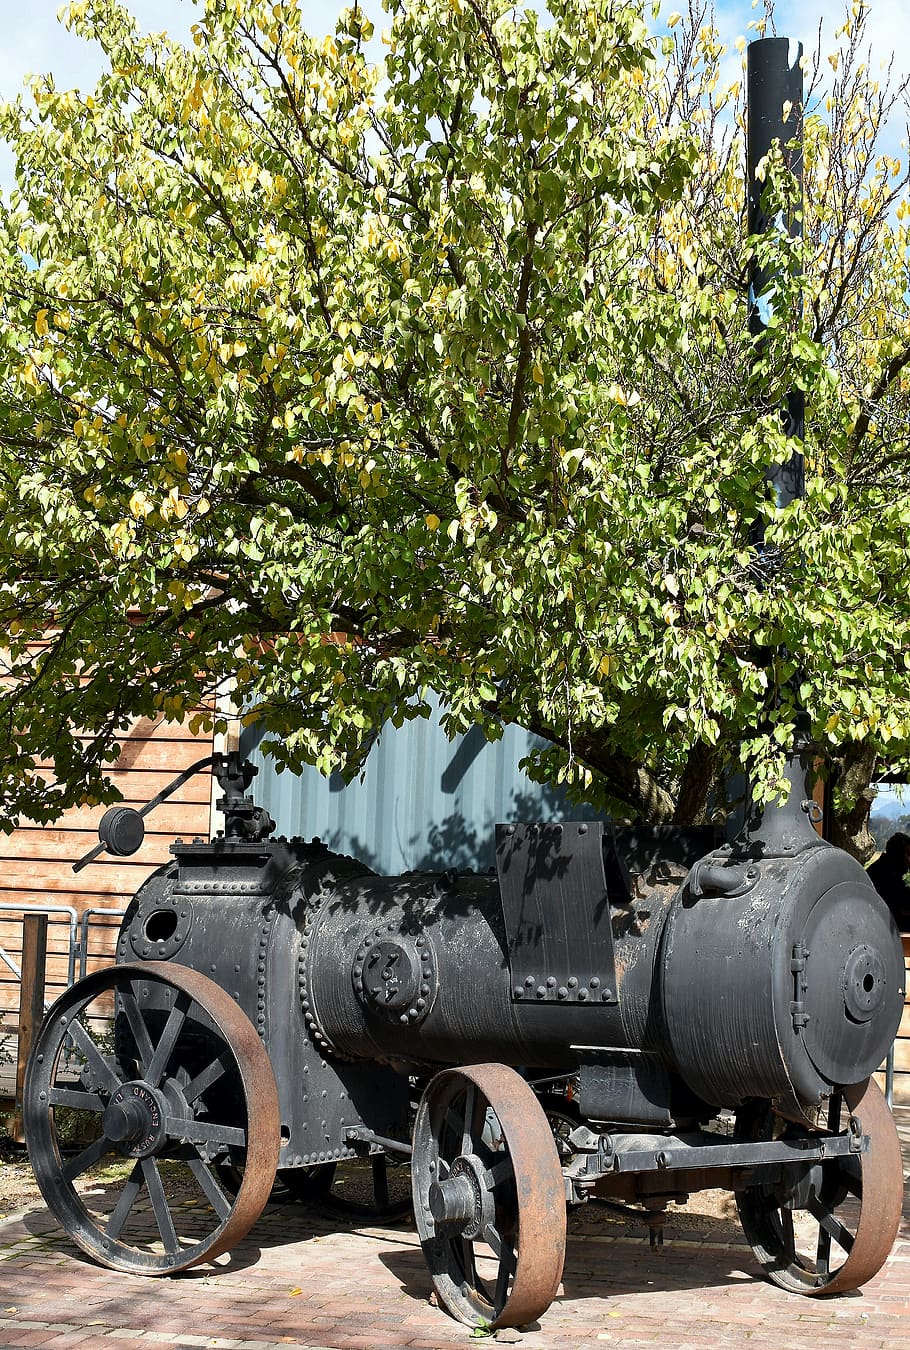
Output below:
[0,720,212,1095]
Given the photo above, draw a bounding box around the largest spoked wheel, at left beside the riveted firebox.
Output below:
[24,963,281,1274]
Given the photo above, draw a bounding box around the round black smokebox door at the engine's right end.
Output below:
[791,882,905,1085]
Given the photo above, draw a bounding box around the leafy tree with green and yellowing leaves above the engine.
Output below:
[0,0,910,847]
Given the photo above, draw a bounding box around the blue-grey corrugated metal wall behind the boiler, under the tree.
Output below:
[242,696,597,875]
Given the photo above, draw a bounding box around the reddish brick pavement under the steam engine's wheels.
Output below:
[0,1111,910,1350]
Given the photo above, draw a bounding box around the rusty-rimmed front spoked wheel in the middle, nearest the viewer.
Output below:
[410,1064,566,1327]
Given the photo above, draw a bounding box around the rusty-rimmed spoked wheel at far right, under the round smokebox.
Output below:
[736,1079,903,1295]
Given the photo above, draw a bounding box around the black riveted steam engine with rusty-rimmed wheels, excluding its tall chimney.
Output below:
[27,756,903,1324]
